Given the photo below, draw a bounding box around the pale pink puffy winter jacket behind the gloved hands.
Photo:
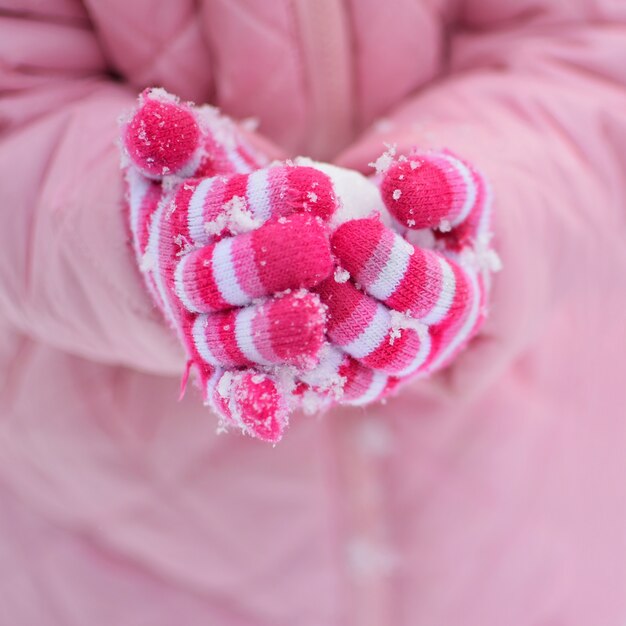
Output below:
[0,0,626,626]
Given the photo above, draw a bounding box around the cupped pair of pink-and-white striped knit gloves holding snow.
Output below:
[122,90,497,442]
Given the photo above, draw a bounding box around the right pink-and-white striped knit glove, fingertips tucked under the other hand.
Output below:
[320,146,498,386]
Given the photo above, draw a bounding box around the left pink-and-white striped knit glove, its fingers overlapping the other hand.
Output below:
[123,90,346,441]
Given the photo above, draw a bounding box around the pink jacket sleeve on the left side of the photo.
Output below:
[0,0,182,373]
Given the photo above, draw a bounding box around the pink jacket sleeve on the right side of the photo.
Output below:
[338,0,626,392]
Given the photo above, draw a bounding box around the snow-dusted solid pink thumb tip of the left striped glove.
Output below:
[124,90,200,177]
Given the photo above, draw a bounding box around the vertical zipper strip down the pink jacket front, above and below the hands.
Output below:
[292,6,391,626]
